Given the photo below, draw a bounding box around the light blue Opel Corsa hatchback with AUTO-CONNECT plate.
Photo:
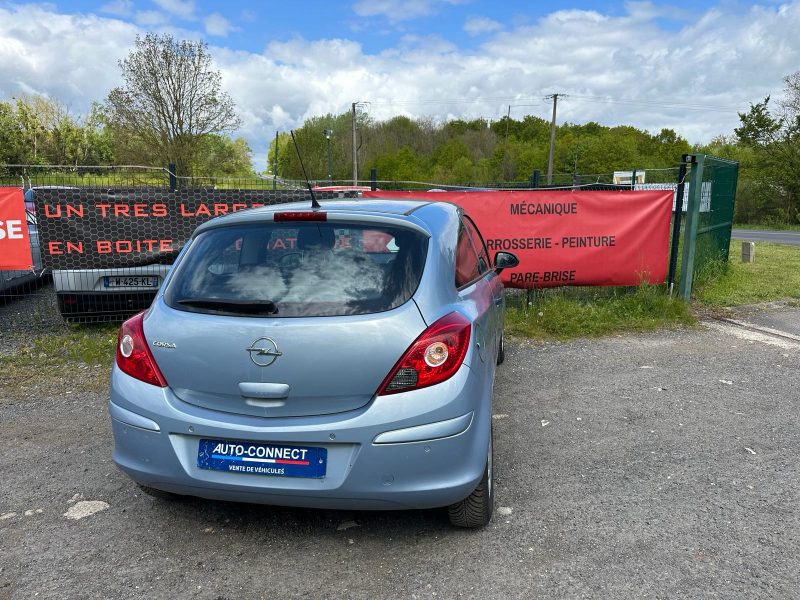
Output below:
[109,200,518,527]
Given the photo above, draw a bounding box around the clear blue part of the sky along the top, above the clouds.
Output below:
[61,0,700,53]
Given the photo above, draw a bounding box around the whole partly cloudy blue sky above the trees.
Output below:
[0,0,800,167]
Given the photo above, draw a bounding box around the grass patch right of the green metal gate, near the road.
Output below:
[695,242,800,307]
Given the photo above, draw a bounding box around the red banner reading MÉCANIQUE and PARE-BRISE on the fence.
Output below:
[363,190,673,288]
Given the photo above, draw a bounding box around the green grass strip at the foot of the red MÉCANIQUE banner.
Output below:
[506,284,695,340]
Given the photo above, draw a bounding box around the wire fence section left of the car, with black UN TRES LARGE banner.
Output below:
[0,165,356,332]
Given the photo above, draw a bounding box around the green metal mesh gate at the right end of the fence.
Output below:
[676,154,739,301]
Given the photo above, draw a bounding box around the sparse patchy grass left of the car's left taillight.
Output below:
[0,324,119,393]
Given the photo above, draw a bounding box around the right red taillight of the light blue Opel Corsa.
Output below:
[378,312,471,396]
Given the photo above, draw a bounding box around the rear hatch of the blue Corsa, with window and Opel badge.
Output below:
[144,216,428,417]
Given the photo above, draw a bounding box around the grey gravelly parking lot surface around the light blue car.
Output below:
[0,312,800,599]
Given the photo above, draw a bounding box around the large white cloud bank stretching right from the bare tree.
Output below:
[217,2,800,169]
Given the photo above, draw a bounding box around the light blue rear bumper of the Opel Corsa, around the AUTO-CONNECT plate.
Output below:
[109,366,491,510]
